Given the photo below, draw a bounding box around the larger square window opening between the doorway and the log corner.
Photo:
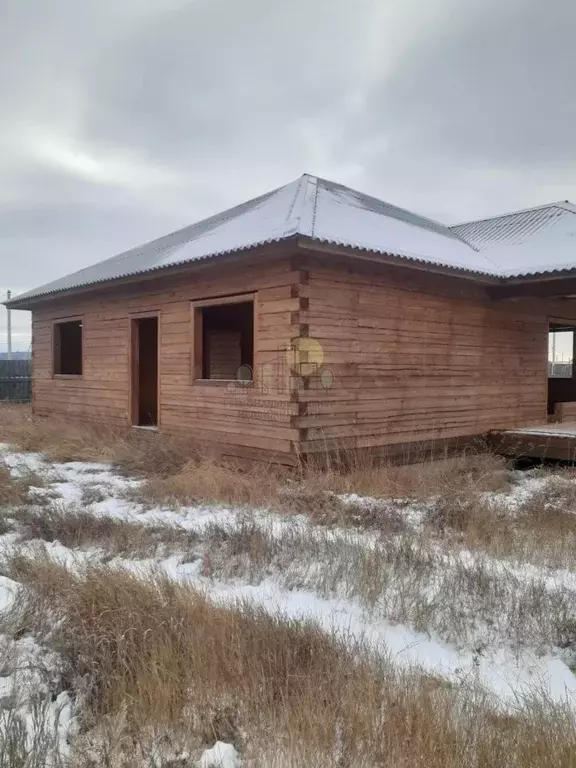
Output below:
[196,301,254,382]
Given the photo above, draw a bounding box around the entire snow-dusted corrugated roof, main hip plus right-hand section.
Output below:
[6,174,576,305]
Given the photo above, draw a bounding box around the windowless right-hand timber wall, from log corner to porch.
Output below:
[298,257,576,451]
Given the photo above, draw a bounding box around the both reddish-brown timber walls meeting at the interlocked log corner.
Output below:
[33,250,576,463]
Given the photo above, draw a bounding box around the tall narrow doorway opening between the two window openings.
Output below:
[132,317,158,427]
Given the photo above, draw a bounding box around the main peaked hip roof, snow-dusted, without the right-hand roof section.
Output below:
[5,174,490,304]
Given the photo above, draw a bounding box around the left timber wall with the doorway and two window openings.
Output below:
[33,254,301,458]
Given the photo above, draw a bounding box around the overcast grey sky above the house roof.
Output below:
[0,0,576,349]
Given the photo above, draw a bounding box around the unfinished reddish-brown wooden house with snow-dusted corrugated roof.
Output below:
[9,175,576,463]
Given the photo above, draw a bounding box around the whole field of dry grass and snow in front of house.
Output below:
[0,406,576,768]
